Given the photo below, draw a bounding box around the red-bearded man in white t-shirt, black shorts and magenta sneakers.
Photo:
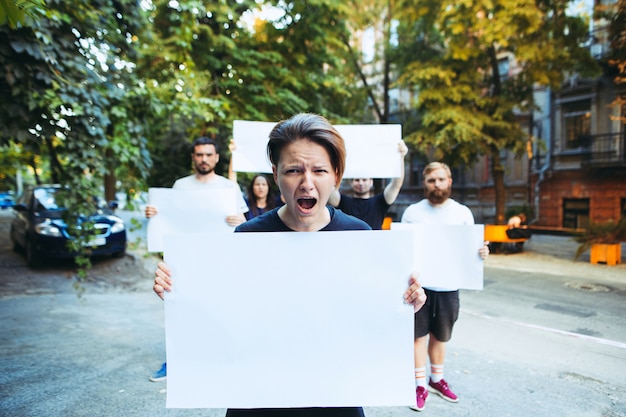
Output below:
[402,162,489,411]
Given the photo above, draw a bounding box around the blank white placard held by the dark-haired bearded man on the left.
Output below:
[147,188,237,252]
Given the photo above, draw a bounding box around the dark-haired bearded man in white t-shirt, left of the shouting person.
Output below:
[145,137,248,382]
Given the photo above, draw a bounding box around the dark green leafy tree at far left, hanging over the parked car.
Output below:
[0,0,149,275]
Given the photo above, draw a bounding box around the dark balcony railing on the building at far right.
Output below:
[580,133,626,166]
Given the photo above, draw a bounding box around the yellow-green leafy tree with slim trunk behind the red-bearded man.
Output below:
[397,0,598,223]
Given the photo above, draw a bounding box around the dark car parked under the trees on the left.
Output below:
[11,185,126,267]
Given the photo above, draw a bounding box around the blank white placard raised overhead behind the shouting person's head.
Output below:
[232,120,402,178]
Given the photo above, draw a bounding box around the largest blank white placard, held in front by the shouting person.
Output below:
[165,231,415,408]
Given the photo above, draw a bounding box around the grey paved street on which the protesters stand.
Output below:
[0,211,626,417]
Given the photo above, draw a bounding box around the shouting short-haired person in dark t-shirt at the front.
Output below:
[153,113,425,417]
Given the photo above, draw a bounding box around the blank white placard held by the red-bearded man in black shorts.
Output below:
[391,222,484,290]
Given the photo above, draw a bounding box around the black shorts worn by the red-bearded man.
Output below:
[414,288,460,342]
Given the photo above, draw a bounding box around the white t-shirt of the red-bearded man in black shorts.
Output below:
[402,198,474,291]
